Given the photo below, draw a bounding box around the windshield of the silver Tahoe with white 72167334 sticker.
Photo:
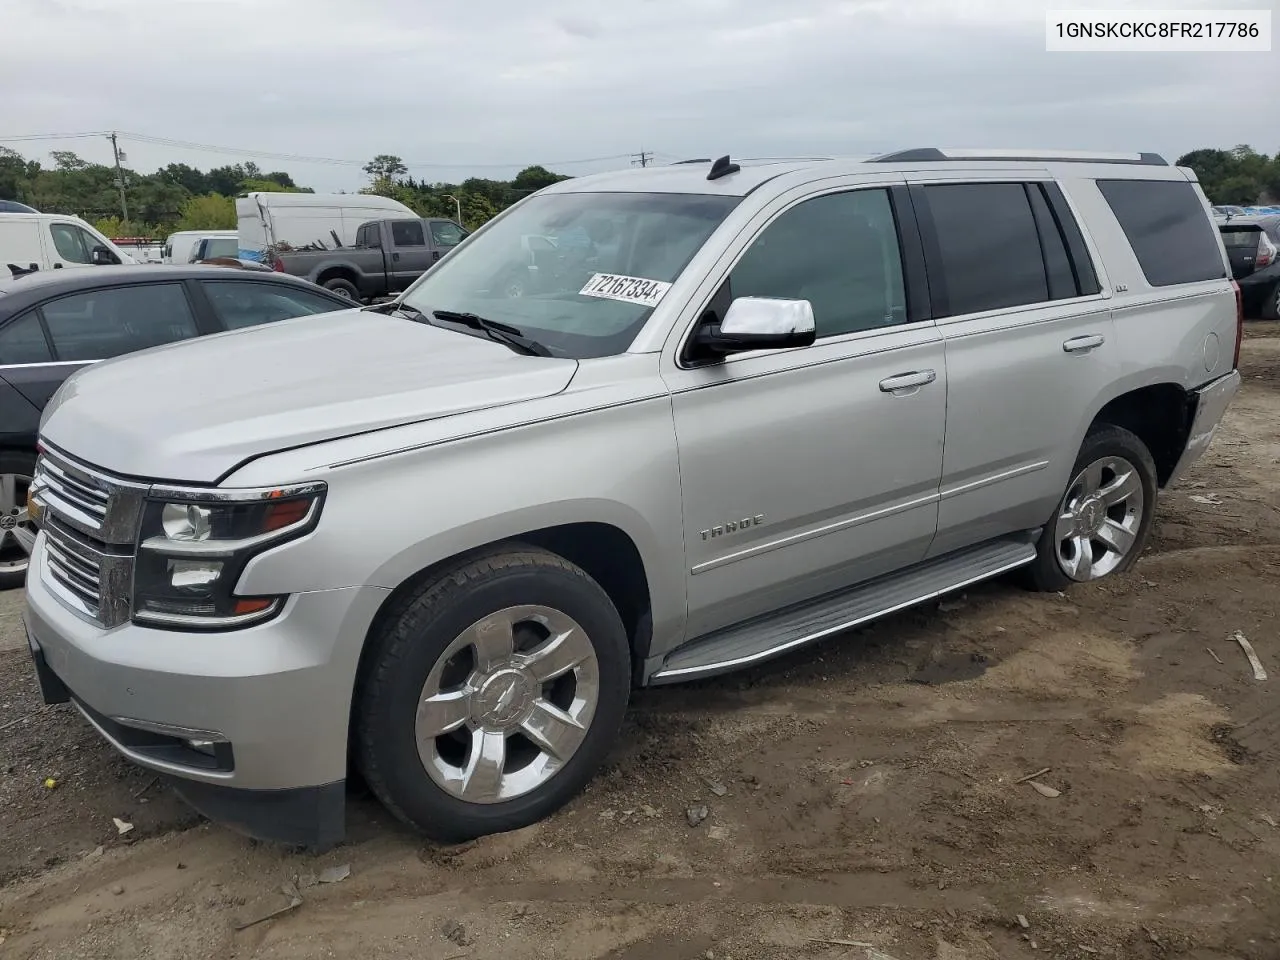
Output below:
[402,193,739,360]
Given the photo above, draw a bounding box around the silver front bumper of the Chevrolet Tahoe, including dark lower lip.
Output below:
[24,535,388,845]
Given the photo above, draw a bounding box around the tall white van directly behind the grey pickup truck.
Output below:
[236,192,417,260]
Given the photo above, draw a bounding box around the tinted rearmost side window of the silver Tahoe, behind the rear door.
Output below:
[1098,180,1226,287]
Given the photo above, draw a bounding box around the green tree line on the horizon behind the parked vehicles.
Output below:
[0,145,1280,245]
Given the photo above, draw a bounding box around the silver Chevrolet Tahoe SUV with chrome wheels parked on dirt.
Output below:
[26,148,1242,847]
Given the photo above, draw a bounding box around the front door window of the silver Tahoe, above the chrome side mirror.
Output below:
[730,189,906,338]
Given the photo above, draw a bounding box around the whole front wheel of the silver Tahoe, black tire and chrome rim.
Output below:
[353,544,631,842]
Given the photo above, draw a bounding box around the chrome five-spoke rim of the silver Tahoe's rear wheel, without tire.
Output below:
[1055,457,1146,582]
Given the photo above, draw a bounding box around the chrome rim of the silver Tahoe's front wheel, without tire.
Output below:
[415,604,600,804]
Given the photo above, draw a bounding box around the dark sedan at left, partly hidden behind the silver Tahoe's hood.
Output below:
[0,266,349,588]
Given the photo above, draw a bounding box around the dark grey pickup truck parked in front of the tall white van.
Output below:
[274,218,467,302]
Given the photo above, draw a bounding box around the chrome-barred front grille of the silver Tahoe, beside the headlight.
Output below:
[31,449,147,627]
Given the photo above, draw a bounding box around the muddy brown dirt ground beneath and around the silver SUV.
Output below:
[0,324,1280,960]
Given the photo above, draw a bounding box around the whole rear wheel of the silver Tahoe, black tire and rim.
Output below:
[1025,424,1158,591]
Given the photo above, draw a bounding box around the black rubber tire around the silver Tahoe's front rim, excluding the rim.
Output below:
[361,566,631,840]
